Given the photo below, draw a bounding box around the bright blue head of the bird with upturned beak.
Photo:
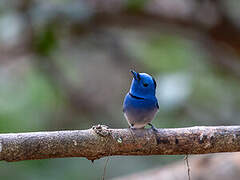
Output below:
[130,70,157,97]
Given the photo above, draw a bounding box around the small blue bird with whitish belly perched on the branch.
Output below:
[123,70,159,131]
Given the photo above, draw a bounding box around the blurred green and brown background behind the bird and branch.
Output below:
[0,0,240,180]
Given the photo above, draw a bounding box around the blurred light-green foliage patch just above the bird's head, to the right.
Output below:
[129,34,195,73]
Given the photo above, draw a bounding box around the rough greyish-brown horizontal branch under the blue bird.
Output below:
[0,125,240,162]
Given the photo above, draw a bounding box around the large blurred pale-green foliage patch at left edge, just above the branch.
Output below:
[0,66,63,132]
